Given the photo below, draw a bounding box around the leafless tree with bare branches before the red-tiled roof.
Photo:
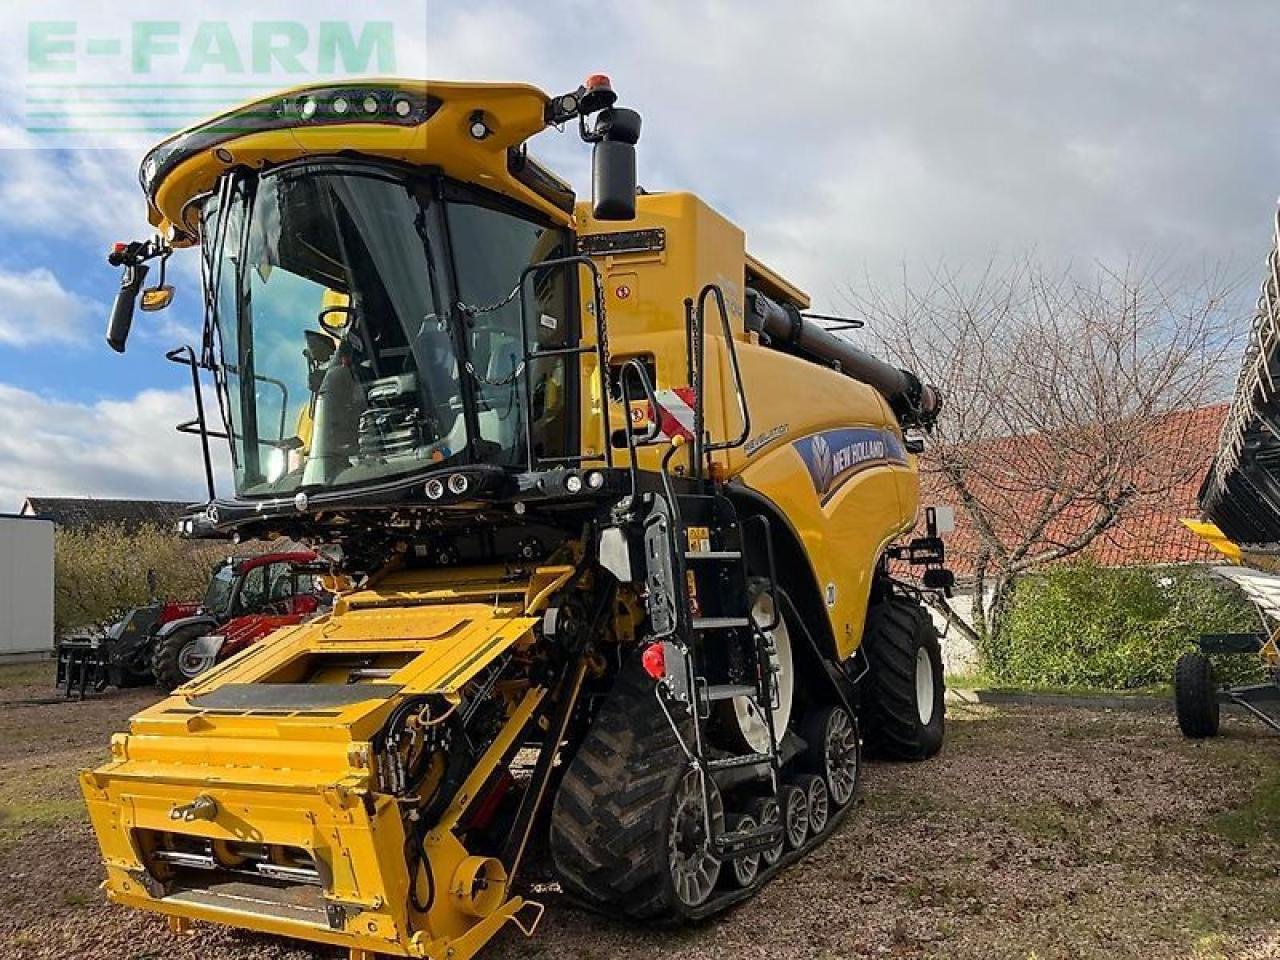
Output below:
[849,256,1238,641]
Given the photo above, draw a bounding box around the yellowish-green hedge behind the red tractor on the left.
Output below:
[54,524,227,632]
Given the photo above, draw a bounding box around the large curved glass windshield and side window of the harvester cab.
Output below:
[204,165,573,497]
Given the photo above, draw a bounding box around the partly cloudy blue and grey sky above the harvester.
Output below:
[0,0,1280,512]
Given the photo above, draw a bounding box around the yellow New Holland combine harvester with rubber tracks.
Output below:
[83,77,950,960]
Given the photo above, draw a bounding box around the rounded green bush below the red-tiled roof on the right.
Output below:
[983,563,1258,690]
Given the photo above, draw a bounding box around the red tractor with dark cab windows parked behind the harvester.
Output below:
[151,550,330,692]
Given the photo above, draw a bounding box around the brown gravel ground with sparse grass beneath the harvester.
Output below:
[0,668,1280,960]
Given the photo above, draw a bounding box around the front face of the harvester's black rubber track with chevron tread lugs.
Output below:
[550,658,723,923]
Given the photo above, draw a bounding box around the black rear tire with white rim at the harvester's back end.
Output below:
[861,596,946,760]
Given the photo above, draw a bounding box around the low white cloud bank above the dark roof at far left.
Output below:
[0,384,229,511]
